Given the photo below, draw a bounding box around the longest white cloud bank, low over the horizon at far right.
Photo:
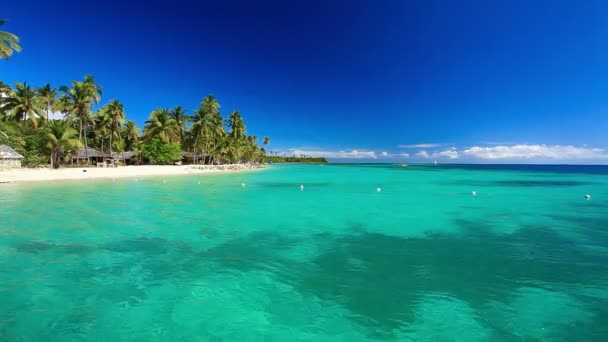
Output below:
[462,144,608,161]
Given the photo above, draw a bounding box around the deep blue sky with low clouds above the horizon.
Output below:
[0,0,608,163]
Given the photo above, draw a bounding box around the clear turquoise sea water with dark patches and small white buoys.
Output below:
[0,165,608,341]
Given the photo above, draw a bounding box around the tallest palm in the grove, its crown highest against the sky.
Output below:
[60,75,102,161]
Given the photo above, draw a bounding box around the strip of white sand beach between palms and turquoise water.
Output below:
[0,164,266,185]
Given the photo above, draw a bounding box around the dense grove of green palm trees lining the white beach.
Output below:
[0,76,270,167]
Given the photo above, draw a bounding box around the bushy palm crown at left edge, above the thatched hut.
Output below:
[2,82,45,128]
